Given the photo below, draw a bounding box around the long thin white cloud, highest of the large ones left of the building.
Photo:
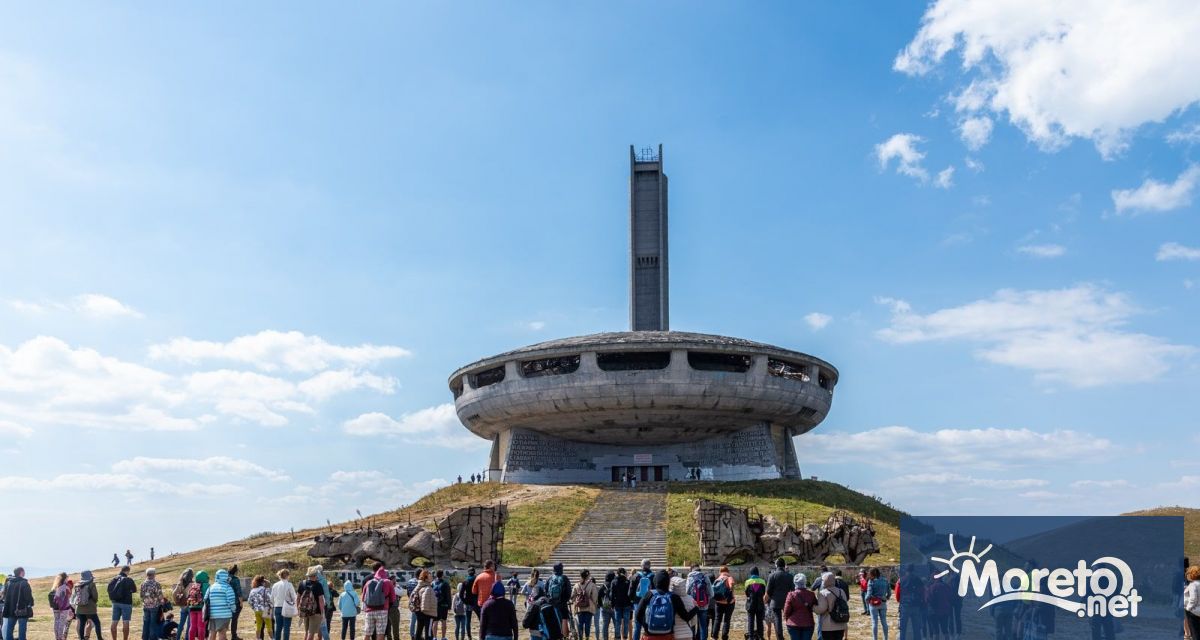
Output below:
[150,330,410,373]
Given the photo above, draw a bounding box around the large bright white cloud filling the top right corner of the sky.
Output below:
[894,0,1200,157]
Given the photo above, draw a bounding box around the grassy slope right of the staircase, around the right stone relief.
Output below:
[667,480,901,564]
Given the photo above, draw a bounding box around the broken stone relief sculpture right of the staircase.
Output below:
[695,498,880,566]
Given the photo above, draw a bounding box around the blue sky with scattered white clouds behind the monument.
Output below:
[0,0,1200,570]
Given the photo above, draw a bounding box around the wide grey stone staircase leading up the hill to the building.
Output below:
[547,485,667,575]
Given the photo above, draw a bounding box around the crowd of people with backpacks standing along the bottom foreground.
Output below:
[7,560,1200,640]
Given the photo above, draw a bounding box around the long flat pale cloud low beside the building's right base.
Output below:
[797,426,1118,469]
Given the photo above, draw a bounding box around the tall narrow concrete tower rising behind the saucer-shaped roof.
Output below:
[629,144,670,331]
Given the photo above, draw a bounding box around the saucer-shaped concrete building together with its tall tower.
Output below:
[450,145,838,483]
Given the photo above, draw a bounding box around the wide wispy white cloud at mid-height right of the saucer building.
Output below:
[876,285,1195,387]
